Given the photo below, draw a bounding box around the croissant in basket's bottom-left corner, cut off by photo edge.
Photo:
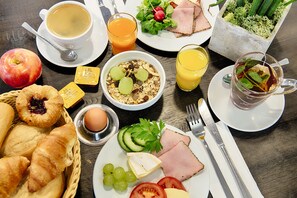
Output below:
[0,156,30,198]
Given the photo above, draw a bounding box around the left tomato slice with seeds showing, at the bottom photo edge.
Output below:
[130,182,167,198]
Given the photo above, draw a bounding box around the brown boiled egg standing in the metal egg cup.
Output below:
[84,107,108,132]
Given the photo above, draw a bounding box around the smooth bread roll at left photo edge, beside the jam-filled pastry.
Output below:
[0,102,14,148]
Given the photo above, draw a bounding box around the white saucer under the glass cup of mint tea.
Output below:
[208,66,285,132]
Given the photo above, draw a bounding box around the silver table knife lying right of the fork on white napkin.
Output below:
[198,98,252,198]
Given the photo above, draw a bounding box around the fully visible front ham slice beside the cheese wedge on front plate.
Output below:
[159,141,204,181]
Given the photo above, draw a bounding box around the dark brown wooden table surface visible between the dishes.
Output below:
[0,0,297,198]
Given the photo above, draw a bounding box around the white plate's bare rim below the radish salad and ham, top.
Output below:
[126,0,219,52]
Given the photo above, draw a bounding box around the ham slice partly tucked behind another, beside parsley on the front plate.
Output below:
[155,128,191,157]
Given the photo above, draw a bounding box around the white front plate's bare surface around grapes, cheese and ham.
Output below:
[93,125,209,198]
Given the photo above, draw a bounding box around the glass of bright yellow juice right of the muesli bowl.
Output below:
[176,44,209,91]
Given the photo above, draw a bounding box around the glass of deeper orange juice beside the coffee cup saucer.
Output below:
[107,12,137,54]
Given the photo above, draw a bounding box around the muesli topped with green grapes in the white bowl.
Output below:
[106,59,160,104]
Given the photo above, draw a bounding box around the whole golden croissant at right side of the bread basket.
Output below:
[28,123,76,192]
